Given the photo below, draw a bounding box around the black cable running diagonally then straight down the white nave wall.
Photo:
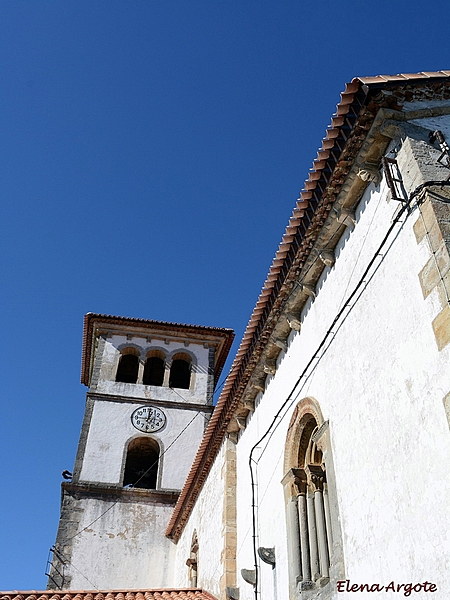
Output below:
[248,176,450,600]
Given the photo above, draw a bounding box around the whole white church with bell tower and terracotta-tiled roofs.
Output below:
[3,71,450,600]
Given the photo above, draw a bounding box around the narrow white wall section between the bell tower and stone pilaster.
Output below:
[174,445,225,598]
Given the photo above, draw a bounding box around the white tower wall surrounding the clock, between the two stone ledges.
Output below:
[80,400,205,489]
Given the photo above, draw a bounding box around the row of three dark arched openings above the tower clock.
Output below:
[116,347,192,390]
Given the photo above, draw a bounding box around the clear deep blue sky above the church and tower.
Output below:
[0,0,450,590]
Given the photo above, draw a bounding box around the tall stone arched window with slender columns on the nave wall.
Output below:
[283,398,340,592]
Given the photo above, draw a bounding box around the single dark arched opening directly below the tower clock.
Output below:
[123,437,159,490]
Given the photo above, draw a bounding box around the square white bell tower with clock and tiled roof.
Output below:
[48,313,234,589]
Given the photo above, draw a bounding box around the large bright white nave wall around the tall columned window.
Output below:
[237,134,450,600]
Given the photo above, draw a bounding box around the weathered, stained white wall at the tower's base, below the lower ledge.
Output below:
[66,498,175,590]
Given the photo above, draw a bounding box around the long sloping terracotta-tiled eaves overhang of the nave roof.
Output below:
[166,71,450,540]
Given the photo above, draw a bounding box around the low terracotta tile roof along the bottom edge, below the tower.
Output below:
[0,588,216,600]
